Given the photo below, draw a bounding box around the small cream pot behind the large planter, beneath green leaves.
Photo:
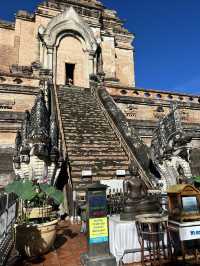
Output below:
[24,205,52,219]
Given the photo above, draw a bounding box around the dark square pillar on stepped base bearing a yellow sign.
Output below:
[81,182,117,266]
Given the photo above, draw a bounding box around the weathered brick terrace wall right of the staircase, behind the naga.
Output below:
[106,84,200,147]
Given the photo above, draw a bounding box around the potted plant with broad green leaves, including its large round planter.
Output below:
[5,180,63,257]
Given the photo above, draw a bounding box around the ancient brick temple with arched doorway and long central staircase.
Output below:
[0,0,200,200]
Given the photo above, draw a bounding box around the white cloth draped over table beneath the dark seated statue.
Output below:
[109,215,141,263]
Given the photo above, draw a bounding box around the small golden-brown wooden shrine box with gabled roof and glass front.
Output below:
[167,184,200,223]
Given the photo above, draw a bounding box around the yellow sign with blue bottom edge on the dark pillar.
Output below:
[89,217,108,244]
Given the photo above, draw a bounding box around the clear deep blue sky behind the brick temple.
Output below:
[0,0,200,95]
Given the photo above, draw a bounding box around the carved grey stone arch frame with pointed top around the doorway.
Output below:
[39,7,97,86]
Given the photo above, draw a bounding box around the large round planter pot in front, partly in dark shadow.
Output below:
[15,220,58,257]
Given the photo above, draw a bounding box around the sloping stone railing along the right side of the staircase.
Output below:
[90,81,154,189]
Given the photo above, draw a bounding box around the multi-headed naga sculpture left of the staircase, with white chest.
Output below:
[13,81,60,182]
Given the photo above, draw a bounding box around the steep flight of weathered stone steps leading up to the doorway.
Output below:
[57,86,129,188]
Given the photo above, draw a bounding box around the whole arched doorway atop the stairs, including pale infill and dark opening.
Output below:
[39,7,97,87]
